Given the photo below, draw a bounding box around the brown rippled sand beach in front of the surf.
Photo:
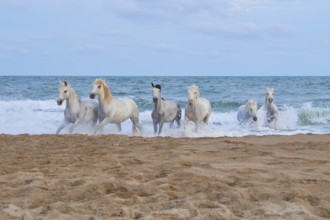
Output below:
[0,135,330,220]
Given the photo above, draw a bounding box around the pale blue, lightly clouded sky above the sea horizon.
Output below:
[0,0,330,76]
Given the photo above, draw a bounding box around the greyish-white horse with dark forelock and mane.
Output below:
[151,83,181,134]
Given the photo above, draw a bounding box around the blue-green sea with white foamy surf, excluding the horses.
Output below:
[0,76,330,137]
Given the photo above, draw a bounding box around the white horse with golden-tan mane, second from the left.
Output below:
[90,79,142,134]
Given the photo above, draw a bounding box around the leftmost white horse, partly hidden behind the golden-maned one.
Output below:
[56,81,98,134]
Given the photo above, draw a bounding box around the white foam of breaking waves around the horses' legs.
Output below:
[0,100,330,137]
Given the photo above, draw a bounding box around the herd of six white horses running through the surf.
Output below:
[56,79,278,134]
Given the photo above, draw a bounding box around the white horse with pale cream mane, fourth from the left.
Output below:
[184,84,211,130]
